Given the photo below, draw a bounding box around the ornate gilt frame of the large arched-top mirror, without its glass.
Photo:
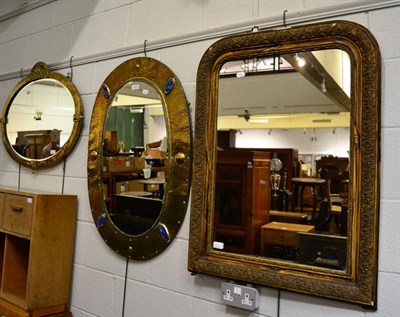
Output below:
[188,21,381,308]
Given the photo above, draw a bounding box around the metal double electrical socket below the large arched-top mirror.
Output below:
[221,282,260,311]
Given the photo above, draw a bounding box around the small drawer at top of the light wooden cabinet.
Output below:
[2,194,33,237]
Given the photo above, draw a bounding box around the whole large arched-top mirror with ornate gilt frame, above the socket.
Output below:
[188,21,380,308]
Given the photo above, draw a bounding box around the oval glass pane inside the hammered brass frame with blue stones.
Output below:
[103,80,168,235]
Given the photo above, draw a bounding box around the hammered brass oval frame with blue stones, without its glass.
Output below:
[88,57,192,261]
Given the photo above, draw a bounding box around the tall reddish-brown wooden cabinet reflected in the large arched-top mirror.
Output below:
[214,150,270,254]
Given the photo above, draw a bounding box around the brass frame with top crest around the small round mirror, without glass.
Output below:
[1,62,84,171]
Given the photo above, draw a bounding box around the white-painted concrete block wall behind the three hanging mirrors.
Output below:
[0,0,400,317]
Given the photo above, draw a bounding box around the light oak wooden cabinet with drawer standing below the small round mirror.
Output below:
[0,188,77,316]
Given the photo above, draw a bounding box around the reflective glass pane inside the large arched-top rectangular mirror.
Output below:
[212,49,351,270]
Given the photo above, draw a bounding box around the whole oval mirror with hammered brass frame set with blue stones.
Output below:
[88,58,191,260]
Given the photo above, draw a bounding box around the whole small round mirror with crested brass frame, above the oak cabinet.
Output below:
[1,62,84,170]
